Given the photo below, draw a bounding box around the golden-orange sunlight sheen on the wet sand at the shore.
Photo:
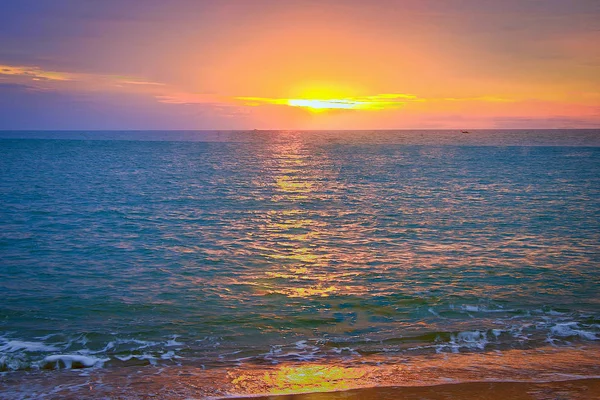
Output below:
[228,346,600,395]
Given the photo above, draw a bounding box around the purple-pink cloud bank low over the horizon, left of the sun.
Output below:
[0,83,253,130]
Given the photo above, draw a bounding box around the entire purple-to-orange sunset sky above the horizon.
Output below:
[0,0,600,130]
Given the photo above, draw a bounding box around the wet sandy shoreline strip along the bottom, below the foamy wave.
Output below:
[0,344,600,400]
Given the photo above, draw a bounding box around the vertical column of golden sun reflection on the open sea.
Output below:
[254,133,344,298]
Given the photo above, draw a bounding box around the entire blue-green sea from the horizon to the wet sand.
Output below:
[0,130,600,396]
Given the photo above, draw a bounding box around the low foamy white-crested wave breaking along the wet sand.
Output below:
[0,307,600,371]
